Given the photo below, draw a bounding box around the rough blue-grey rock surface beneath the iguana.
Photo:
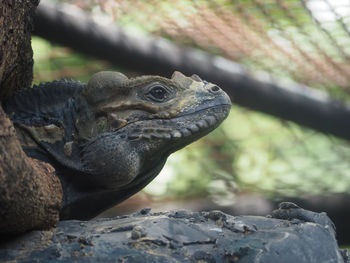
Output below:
[0,203,349,263]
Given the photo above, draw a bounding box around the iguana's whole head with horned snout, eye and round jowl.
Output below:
[78,72,231,190]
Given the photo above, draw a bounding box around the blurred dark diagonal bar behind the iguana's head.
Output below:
[34,4,350,139]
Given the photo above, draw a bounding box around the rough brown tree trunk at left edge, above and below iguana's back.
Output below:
[0,0,62,233]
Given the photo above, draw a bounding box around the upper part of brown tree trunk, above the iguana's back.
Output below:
[0,0,35,100]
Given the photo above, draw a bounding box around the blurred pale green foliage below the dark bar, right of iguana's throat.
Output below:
[151,106,350,203]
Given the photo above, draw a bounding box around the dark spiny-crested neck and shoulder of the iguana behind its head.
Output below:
[4,79,86,170]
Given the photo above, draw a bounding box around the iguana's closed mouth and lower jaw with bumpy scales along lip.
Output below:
[127,104,231,144]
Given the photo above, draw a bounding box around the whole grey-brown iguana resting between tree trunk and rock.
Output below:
[4,71,231,219]
